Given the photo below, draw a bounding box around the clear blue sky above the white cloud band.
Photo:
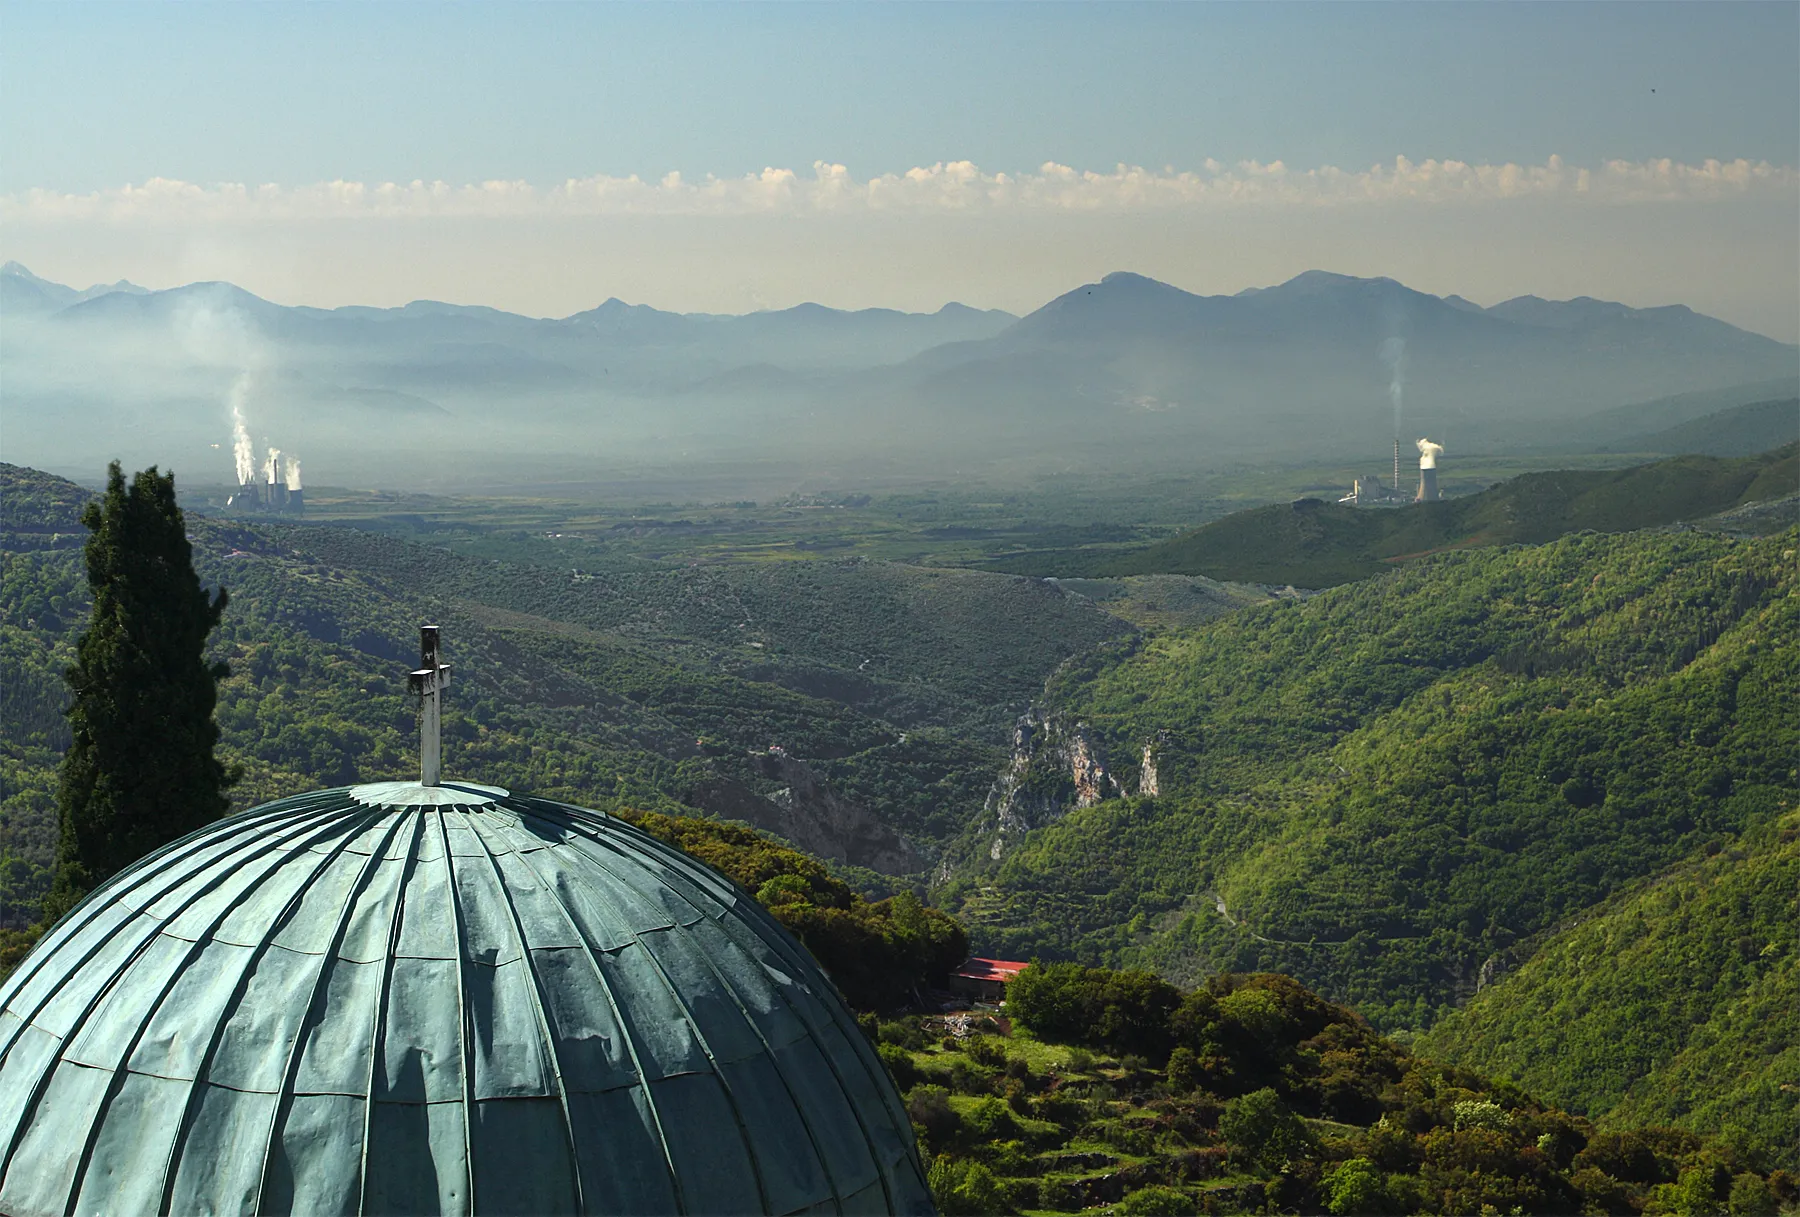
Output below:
[0,4,1800,191]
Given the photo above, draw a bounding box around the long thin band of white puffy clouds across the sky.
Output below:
[0,157,1800,223]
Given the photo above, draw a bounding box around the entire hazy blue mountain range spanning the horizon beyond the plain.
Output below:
[0,263,1800,481]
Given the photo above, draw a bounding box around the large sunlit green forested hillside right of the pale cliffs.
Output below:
[943,531,1800,1026]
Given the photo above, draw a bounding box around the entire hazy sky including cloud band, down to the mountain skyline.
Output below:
[10,2,1800,340]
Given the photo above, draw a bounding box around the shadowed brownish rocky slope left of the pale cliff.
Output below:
[684,749,929,875]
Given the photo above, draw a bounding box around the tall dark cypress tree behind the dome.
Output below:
[45,461,230,920]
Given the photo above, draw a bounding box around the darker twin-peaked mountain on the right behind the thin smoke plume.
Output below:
[889,270,1800,448]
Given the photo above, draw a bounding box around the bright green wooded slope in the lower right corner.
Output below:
[1420,812,1800,1156]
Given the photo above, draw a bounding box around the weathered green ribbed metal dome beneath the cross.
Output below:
[0,787,931,1217]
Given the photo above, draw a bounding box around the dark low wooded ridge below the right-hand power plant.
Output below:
[988,443,1800,587]
